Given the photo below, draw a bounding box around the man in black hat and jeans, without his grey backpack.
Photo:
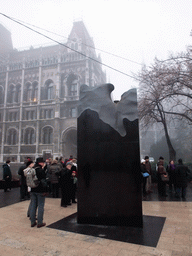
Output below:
[30,157,47,228]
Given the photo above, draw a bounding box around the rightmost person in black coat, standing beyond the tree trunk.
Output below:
[175,158,190,199]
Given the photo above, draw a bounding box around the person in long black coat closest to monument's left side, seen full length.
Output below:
[59,162,73,207]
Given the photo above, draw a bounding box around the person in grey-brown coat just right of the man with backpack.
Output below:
[48,160,61,198]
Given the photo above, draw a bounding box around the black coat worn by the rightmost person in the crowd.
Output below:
[175,164,190,187]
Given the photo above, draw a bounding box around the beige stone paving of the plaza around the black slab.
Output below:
[0,189,192,256]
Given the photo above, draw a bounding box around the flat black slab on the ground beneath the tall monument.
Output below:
[48,213,166,247]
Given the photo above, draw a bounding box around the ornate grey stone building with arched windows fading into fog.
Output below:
[0,21,106,162]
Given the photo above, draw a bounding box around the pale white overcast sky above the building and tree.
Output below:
[0,0,192,99]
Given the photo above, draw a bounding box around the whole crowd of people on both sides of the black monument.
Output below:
[3,156,190,228]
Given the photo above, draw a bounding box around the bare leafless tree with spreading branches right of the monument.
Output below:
[137,52,192,159]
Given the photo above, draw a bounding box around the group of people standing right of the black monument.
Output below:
[141,156,190,199]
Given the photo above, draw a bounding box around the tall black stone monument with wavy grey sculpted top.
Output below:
[77,84,143,227]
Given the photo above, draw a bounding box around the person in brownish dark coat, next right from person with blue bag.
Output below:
[157,160,168,197]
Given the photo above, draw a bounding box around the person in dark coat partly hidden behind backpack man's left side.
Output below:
[18,159,31,201]
